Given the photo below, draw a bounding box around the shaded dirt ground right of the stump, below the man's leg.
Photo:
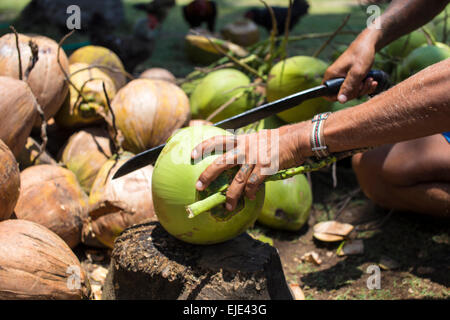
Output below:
[251,163,450,300]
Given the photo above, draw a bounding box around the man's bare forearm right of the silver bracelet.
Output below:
[308,59,450,156]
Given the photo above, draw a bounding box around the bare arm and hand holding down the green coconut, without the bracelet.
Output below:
[192,59,450,210]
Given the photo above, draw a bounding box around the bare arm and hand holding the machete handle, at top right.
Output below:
[324,0,450,103]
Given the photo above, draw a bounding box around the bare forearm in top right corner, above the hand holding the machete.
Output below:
[362,0,450,51]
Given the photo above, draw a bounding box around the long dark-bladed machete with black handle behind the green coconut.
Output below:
[113,70,390,179]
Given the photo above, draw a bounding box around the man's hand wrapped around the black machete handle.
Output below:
[323,29,378,103]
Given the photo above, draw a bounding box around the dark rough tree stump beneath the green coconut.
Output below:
[103,222,293,300]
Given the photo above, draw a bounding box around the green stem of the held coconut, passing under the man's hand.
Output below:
[186,148,370,218]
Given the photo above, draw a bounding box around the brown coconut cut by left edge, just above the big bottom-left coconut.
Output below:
[0,140,20,221]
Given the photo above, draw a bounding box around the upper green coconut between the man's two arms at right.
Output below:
[386,28,435,58]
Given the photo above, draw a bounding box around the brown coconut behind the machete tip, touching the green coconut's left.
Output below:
[83,153,156,248]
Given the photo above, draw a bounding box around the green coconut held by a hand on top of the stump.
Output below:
[152,126,264,244]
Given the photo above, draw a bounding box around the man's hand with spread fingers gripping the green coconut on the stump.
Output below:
[191,123,311,211]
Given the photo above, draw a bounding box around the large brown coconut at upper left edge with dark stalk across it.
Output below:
[0,33,69,125]
